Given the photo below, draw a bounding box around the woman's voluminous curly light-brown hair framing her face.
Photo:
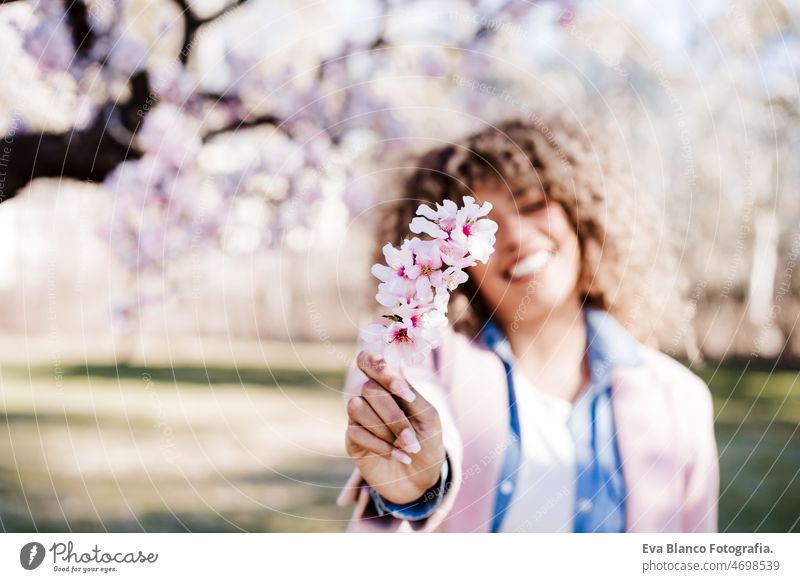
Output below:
[375,111,691,349]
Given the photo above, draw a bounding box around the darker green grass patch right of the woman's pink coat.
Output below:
[695,362,800,532]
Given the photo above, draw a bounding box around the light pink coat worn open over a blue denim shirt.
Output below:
[337,328,719,532]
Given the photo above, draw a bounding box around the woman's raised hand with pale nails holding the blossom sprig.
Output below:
[345,351,445,503]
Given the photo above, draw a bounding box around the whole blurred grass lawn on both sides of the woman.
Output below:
[0,356,800,531]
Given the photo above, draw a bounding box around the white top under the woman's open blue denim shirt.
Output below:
[500,366,577,532]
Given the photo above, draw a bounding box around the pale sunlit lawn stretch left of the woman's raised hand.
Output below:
[0,365,352,531]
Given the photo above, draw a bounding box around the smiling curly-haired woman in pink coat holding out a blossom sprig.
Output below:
[338,114,719,532]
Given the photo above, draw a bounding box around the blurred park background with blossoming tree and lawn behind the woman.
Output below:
[0,0,800,532]
